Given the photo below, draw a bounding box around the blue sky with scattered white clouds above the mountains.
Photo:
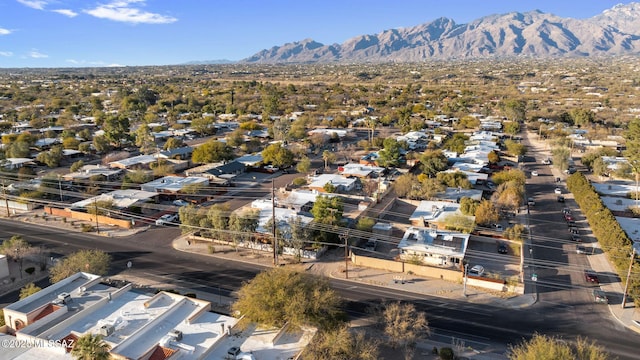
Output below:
[0,0,631,68]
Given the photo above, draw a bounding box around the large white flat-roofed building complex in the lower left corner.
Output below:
[0,272,312,360]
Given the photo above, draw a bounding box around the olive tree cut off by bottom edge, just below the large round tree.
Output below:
[302,325,379,360]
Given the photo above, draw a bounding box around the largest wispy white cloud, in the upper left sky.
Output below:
[85,0,178,24]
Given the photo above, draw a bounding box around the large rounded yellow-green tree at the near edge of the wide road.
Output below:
[232,268,344,330]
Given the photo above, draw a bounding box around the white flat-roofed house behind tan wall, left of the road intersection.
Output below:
[398,226,469,268]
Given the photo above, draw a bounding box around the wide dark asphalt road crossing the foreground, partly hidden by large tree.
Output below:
[0,219,640,359]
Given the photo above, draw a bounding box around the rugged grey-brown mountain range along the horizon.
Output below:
[240,3,640,64]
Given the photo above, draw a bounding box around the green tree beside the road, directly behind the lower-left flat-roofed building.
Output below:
[49,250,111,283]
